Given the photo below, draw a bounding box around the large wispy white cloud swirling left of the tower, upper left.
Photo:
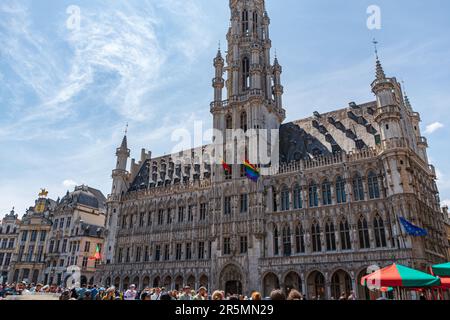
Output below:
[0,0,210,140]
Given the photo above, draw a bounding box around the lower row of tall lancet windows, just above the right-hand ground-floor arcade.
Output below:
[273,215,387,256]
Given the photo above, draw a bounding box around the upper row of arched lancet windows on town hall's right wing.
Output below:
[274,171,380,211]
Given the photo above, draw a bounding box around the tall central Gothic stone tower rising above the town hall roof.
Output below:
[211,0,286,178]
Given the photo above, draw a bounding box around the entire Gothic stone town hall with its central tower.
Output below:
[96,0,448,299]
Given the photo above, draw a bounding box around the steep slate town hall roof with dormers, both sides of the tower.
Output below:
[128,101,380,192]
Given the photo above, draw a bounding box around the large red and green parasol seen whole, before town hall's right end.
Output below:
[361,264,441,288]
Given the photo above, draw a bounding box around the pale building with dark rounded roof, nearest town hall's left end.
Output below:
[44,186,106,285]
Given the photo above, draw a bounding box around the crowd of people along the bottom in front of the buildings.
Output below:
[0,282,356,301]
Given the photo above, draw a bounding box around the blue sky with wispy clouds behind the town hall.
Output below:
[0,0,450,216]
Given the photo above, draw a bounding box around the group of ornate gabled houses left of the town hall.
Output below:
[4,186,106,285]
